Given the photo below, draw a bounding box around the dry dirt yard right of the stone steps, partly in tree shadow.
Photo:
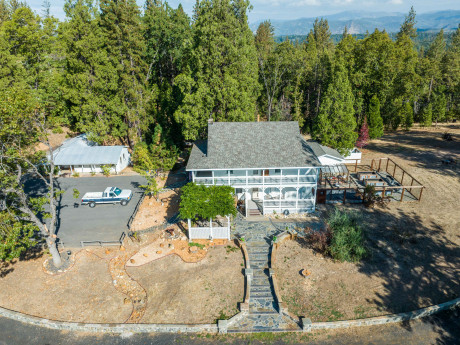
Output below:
[276,125,460,321]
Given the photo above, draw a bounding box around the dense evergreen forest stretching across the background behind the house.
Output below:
[0,0,460,153]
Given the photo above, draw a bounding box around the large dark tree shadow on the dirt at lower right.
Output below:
[352,206,460,343]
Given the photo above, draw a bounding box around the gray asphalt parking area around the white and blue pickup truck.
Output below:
[27,176,145,247]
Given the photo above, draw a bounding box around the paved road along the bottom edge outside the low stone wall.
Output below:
[0,309,460,345]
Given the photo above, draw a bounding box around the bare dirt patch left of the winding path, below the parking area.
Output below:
[0,249,132,323]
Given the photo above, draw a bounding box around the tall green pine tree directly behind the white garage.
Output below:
[60,0,121,143]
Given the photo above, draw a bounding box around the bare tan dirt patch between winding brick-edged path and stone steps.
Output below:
[127,246,244,323]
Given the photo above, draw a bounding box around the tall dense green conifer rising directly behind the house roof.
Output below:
[175,0,260,139]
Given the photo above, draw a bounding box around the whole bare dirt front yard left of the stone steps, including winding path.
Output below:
[0,229,244,323]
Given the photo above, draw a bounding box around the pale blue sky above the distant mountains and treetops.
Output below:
[27,0,460,22]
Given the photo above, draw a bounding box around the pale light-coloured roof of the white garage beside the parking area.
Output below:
[53,135,124,166]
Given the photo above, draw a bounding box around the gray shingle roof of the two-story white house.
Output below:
[187,121,321,170]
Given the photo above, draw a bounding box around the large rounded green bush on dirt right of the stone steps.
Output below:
[327,209,367,262]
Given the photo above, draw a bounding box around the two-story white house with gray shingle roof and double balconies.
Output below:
[186,120,321,216]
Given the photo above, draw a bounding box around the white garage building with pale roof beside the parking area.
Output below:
[53,134,130,174]
